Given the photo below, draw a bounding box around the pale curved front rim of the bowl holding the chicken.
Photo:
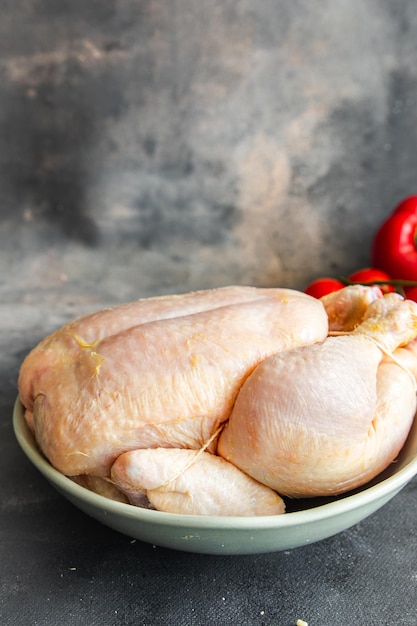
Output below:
[13,396,417,530]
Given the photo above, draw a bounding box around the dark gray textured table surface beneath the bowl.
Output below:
[0,316,417,626]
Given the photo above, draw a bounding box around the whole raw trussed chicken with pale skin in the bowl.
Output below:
[19,287,417,515]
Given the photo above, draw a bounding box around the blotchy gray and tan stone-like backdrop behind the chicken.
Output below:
[0,0,417,304]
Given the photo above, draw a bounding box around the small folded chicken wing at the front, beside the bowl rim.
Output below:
[111,448,285,516]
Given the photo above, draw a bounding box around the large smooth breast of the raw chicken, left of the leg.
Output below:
[19,287,328,477]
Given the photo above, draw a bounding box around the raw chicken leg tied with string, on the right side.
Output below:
[217,292,417,497]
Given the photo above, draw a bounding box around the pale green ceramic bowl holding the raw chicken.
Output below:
[13,399,417,554]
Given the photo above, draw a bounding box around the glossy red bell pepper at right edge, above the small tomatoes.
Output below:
[372,196,417,280]
